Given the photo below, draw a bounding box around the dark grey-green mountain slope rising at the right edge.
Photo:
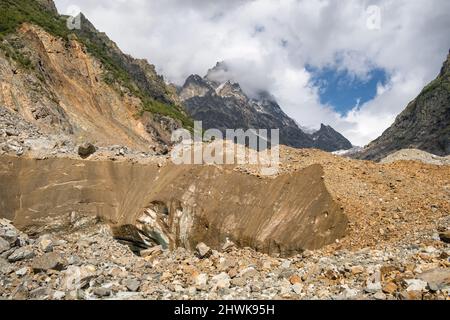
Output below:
[356,53,450,160]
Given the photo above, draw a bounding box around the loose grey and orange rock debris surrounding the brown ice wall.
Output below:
[0,105,450,300]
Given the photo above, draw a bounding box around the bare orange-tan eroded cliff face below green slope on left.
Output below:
[0,24,166,149]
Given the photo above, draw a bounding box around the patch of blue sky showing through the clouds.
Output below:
[306,66,388,115]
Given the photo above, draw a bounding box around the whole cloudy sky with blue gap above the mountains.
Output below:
[55,0,450,146]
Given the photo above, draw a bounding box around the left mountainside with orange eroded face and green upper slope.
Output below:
[0,0,192,150]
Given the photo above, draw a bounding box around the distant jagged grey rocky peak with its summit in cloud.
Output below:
[179,62,352,151]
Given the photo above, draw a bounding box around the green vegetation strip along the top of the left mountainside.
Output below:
[0,0,193,128]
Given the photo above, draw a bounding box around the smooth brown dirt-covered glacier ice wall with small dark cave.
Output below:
[0,156,347,256]
